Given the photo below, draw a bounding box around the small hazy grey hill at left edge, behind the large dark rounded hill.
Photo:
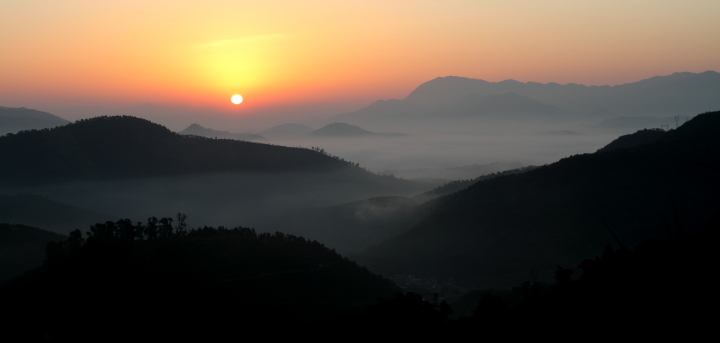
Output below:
[0,106,69,136]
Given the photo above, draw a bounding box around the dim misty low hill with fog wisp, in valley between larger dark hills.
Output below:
[262,196,431,254]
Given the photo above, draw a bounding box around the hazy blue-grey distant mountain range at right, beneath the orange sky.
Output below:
[336,71,720,124]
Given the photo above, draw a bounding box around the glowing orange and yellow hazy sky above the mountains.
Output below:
[0,0,720,114]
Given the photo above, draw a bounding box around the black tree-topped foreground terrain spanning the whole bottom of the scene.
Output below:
[0,216,720,341]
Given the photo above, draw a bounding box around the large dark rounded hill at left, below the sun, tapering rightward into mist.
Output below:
[0,116,368,183]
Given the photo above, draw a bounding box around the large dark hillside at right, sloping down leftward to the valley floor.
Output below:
[361,112,720,287]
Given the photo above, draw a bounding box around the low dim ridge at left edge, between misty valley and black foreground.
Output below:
[0,194,118,234]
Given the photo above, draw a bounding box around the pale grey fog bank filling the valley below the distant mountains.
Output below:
[262,123,619,181]
